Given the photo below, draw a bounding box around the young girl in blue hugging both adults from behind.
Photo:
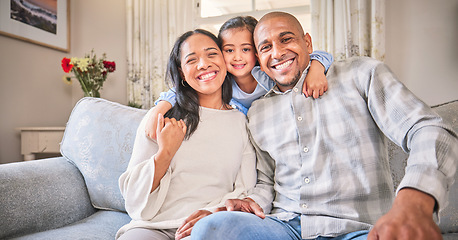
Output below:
[145,16,333,139]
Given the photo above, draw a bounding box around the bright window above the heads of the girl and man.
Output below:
[196,0,311,35]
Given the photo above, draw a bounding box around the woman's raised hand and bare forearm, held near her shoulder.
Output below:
[151,113,187,192]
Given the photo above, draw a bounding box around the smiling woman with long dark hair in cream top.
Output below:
[116,29,256,239]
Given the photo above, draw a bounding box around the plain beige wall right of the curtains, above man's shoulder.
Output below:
[385,0,458,105]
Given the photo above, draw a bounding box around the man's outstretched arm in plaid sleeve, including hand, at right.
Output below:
[359,59,458,239]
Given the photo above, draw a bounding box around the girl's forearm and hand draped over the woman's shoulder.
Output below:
[145,88,176,140]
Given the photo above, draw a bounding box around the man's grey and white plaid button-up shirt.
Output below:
[248,57,458,238]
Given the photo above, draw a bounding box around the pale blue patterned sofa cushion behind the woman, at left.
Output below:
[61,98,146,211]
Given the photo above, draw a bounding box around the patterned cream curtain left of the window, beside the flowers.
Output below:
[126,0,195,109]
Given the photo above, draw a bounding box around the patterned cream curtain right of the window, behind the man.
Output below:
[311,0,385,61]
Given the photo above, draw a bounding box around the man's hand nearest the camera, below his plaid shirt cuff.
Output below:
[367,188,442,240]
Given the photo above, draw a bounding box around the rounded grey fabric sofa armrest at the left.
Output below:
[0,157,95,239]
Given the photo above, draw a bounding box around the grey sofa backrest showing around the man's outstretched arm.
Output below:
[388,100,458,233]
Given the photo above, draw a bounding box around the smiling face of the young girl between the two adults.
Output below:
[221,28,257,78]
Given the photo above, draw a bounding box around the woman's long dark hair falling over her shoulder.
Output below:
[165,29,232,139]
